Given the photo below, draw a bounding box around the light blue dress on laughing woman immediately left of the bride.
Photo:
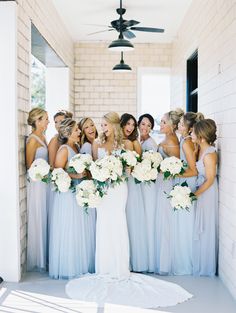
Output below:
[78,142,96,273]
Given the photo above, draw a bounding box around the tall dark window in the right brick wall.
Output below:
[186,50,198,112]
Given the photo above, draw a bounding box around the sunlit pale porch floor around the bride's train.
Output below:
[0,273,236,313]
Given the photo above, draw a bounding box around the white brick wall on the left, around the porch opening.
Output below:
[16,0,74,271]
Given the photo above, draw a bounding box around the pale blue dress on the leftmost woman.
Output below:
[27,134,48,271]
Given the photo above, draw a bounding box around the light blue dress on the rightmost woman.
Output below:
[193,146,219,276]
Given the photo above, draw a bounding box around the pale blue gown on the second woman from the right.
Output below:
[172,137,197,275]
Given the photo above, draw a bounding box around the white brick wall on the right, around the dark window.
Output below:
[171,0,236,298]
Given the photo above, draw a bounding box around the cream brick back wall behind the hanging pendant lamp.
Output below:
[74,43,172,123]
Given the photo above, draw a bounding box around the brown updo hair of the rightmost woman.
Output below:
[193,118,217,146]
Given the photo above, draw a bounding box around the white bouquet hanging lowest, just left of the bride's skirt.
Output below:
[75,180,104,213]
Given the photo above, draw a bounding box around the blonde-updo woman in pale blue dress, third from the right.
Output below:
[155,109,183,275]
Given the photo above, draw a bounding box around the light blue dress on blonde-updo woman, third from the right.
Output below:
[155,146,174,275]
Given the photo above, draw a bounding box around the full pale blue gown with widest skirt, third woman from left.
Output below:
[49,145,94,279]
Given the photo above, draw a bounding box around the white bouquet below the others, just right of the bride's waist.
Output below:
[131,158,158,184]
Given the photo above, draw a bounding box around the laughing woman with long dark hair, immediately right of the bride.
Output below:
[120,113,148,272]
